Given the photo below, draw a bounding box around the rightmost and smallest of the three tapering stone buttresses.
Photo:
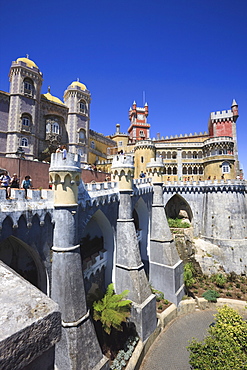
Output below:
[147,158,184,305]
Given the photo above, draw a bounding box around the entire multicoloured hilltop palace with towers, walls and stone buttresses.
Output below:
[0,56,247,370]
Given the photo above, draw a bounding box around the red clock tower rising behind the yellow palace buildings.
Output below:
[128,101,150,143]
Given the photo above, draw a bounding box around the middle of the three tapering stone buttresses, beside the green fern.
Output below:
[112,155,156,341]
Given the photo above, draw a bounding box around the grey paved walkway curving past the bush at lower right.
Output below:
[140,310,216,370]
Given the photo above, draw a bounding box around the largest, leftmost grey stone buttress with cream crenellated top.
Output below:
[49,153,109,370]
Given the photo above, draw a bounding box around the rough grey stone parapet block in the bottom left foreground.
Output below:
[0,261,61,370]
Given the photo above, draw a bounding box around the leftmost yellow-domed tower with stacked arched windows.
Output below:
[6,55,43,159]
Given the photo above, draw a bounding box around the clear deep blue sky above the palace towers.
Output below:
[0,0,247,176]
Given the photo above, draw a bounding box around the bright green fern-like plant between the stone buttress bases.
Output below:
[93,284,131,334]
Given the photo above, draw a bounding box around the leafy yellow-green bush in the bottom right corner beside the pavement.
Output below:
[188,306,247,370]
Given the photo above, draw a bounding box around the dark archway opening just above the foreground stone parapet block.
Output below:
[0,235,47,294]
